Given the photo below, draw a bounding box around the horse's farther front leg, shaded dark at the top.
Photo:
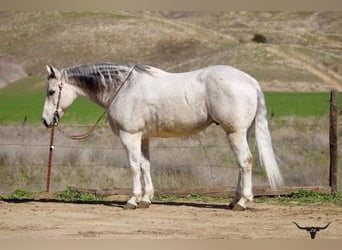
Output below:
[138,139,154,208]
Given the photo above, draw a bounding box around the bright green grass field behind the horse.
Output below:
[0,77,342,124]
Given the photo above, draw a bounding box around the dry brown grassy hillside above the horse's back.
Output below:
[0,11,342,91]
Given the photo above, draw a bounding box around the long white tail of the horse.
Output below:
[255,85,283,188]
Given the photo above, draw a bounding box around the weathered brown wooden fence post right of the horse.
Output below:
[329,89,340,192]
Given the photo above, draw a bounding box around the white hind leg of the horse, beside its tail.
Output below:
[228,130,253,210]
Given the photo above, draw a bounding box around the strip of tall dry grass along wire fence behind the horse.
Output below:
[0,91,341,193]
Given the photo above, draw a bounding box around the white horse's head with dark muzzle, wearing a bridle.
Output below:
[42,65,76,127]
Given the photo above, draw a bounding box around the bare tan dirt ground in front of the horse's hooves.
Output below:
[0,201,342,239]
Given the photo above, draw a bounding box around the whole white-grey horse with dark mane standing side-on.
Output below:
[42,62,282,210]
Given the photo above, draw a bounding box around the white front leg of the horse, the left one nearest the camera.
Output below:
[120,131,142,209]
